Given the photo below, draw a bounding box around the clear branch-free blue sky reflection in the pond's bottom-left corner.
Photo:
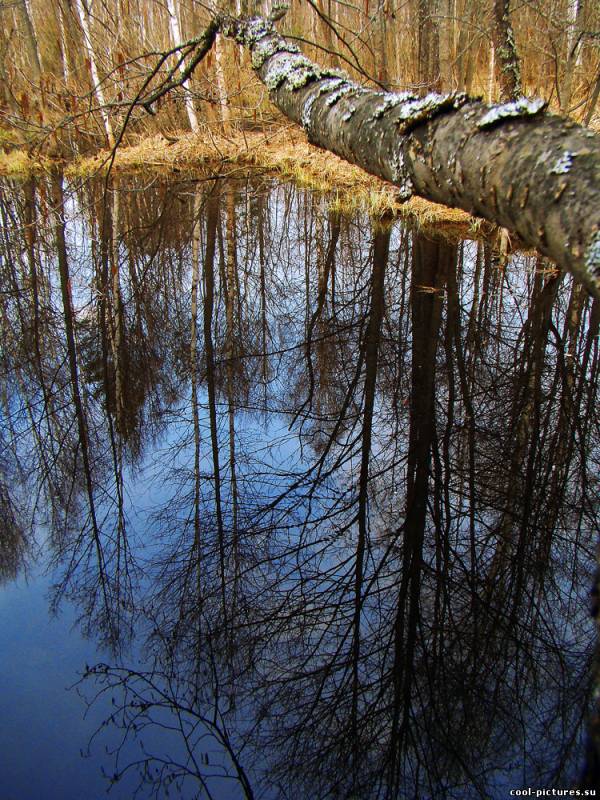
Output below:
[0,573,142,800]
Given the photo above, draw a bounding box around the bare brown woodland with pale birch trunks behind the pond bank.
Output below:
[0,0,600,167]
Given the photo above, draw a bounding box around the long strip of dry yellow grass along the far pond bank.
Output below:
[67,126,479,235]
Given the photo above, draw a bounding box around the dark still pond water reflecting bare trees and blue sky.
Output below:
[0,176,600,800]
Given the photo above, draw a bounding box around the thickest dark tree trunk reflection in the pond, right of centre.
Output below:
[390,233,456,791]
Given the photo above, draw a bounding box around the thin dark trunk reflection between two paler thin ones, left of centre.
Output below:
[203,193,228,630]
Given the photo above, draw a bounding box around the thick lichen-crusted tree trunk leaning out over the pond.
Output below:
[220,17,600,298]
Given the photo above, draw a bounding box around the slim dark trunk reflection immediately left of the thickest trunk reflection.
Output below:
[350,216,391,783]
